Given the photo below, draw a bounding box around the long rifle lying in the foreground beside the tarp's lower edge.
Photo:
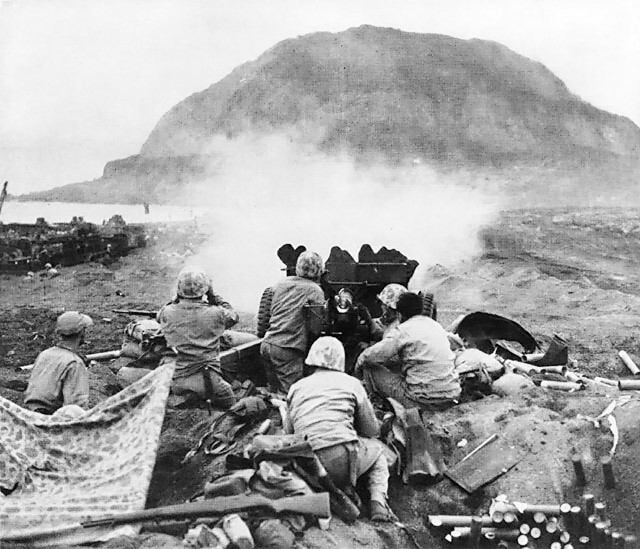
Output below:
[81,492,331,528]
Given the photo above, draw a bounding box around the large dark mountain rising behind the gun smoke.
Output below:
[30,26,640,202]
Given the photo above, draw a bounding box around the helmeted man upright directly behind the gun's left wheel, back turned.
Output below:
[260,251,324,393]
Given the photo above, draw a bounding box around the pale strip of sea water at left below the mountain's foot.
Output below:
[0,201,207,225]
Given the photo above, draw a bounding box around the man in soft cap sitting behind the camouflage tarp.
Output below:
[24,311,93,415]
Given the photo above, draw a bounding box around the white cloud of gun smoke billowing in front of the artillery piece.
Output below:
[176,135,499,312]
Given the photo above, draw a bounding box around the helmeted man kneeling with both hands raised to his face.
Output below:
[157,267,255,409]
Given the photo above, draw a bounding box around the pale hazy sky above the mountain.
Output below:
[0,0,640,194]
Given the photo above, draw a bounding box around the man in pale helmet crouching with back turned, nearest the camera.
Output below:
[285,336,390,520]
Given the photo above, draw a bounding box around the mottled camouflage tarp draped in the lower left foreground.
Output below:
[0,362,175,546]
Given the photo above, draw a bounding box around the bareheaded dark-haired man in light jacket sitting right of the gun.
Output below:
[356,292,460,410]
